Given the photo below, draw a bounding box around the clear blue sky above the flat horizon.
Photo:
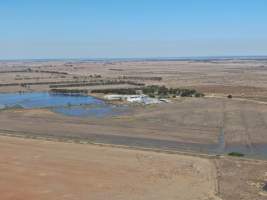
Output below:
[0,0,267,59]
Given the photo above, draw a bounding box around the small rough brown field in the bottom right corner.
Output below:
[215,158,267,200]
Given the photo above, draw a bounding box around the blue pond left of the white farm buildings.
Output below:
[0,92,127,117]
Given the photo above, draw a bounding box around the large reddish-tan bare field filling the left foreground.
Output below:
[0,136,219,200]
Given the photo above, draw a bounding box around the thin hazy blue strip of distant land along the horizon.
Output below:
[0,55,267,62]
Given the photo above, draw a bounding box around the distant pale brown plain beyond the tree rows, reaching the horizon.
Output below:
[0,59,267,100]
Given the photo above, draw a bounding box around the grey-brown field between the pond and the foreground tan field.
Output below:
[0,95,267,157]
